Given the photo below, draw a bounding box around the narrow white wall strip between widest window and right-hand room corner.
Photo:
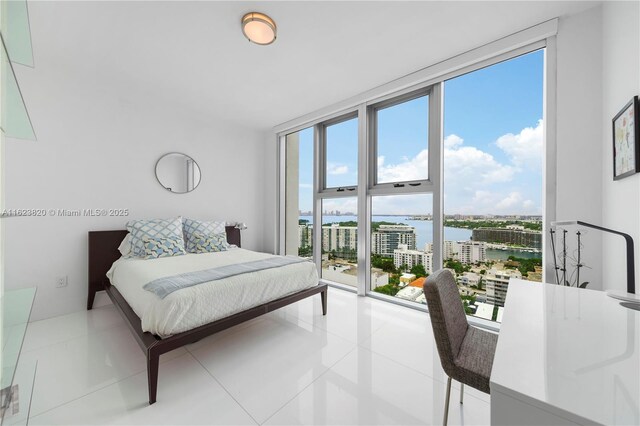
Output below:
[547,6,603,289]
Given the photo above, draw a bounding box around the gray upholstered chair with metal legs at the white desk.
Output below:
[424,269,498,425]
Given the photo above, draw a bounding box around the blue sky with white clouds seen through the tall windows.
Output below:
[300,51,544,214]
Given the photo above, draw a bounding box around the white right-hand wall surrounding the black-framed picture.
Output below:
[600,2,640,296]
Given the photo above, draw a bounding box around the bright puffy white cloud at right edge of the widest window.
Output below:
[496,120,544,171]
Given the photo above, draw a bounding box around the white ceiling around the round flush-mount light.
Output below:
[29,1,596,128]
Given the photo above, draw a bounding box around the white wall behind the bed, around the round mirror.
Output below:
[3,57,265,320]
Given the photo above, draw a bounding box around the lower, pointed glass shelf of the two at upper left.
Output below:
[0,35,36,141]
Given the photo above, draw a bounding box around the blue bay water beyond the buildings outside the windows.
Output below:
[300,215,542,260]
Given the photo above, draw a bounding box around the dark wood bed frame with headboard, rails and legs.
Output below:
[87,226,327,404]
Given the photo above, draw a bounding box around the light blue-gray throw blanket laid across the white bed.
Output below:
[142,256,306,299]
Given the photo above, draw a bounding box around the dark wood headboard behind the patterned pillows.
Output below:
[87,226,240,309]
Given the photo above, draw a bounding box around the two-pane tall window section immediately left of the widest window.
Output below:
[368,88,433,303]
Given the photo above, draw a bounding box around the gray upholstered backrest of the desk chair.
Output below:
[423,269,469,376]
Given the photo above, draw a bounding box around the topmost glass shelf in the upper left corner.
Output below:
[0,0,33,67]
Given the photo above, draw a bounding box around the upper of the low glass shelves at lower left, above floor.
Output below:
[0,288,36,389]
